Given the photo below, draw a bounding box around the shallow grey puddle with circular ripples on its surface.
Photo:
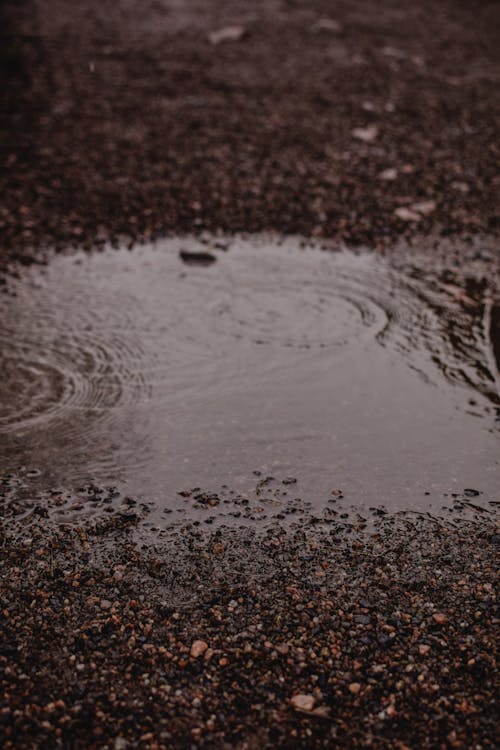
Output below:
[0,238,500,521]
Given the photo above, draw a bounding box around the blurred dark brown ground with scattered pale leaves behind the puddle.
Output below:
[0,0,500,263]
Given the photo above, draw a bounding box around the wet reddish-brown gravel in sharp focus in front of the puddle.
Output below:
[0,514,499,750]
